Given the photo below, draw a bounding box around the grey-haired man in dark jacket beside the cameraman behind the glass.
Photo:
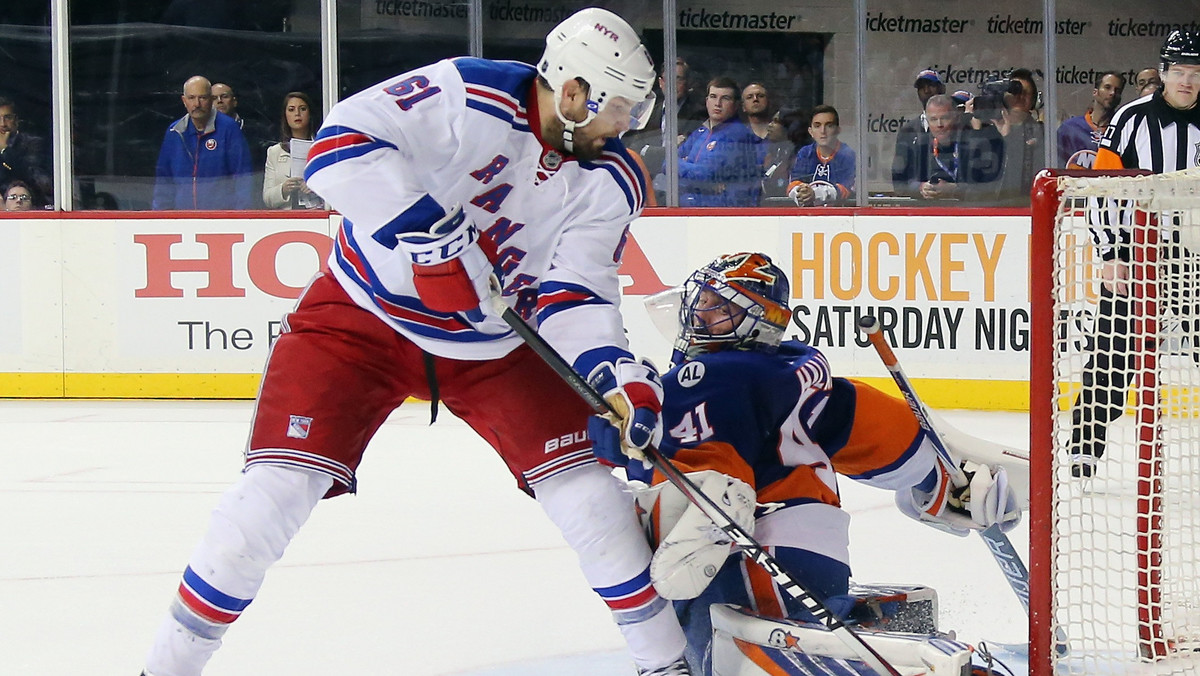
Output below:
[892,94,1004,202]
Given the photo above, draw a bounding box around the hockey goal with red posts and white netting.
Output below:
[1030,169,1200,676]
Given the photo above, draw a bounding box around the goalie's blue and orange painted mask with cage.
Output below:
[673,253,792,364]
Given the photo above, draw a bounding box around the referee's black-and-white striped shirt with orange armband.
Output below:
[1090,90,1200,259]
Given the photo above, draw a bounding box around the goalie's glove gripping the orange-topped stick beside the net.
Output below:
[896,460,1021,537]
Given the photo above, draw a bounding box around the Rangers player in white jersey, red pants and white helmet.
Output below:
[138,8,688,676]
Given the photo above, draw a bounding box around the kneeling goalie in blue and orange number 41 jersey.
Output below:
[594,253,1027,676]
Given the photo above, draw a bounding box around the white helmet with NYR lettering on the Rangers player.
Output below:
[538,7,655,144]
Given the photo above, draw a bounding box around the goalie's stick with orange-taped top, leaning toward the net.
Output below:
[858,315,1068,656]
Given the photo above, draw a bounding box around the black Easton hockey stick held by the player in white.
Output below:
[492,289,900,676]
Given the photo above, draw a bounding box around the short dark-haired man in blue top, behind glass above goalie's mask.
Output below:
[679,77,761,207]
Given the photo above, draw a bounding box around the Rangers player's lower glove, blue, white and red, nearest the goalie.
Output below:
[588,358,662,467]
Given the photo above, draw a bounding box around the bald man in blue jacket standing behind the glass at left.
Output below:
[154,76,254,209]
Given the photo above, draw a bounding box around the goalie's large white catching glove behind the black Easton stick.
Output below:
[635,469,757,600]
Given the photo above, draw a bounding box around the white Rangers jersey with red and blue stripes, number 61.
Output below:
[305,58,646,375]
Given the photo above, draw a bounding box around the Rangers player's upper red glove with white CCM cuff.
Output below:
[398,204,493,322]
